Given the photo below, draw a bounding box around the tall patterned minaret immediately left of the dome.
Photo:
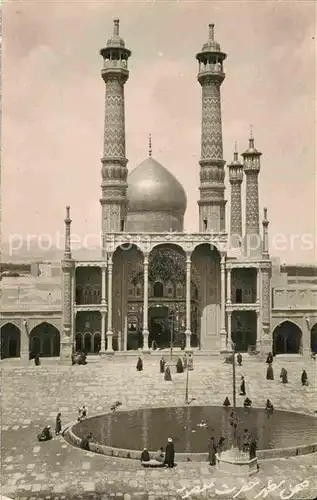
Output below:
[100,19,131,235]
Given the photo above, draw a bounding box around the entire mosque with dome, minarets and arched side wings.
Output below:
[0,19,317,363]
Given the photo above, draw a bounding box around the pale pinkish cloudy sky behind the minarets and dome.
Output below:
[2,0,317,263]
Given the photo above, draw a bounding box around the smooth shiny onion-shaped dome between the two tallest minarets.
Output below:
[128,156,187,215]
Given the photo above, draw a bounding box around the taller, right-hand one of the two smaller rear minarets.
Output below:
[242,127,262,254]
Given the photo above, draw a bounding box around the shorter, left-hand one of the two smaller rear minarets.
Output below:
[228,143,243,248]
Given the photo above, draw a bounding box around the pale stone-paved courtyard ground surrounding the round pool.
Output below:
[1,357,317,500]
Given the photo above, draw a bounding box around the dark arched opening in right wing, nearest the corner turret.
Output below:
[273,321,302,355]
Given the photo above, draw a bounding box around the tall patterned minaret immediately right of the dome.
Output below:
[196,24,227,232]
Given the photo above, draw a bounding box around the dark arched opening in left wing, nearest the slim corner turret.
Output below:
[29,321,60,358]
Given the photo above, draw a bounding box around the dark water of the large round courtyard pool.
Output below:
[70,406,317,457]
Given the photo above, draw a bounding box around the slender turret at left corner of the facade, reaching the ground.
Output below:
[60,207,74,364]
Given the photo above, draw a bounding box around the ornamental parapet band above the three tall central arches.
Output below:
[103,232,228,253]
